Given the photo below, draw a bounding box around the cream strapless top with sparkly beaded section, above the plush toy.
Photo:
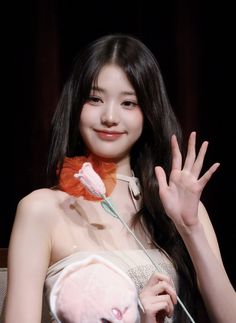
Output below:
[45,249,178,323]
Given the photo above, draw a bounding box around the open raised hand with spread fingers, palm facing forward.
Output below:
[155,132,220,228]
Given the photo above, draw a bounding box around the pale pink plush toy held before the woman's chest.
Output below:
[49,255,140,323]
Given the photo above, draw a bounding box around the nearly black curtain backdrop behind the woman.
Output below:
[0,0,236,287]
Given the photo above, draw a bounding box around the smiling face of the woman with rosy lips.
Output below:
[79,65,143,161]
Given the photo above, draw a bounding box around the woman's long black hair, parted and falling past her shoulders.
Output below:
[47,34,207,323]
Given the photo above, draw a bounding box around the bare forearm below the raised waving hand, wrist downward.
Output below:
[179,222,236,323]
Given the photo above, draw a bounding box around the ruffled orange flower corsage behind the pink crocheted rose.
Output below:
[59,155,116,201]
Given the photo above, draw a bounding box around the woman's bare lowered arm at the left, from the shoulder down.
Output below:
[5,191,50,323]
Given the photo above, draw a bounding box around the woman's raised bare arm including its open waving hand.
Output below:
[155,132,236,323]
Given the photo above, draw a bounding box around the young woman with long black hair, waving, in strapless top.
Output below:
[6,35,236,323]
